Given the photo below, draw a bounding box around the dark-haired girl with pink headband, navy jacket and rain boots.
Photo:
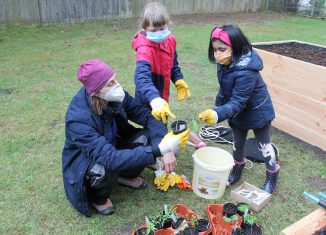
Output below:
[198,25,280,193]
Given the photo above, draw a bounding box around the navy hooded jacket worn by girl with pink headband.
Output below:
[214,50,275,130]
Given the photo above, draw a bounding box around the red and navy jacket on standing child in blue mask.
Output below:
[131,31,183,104]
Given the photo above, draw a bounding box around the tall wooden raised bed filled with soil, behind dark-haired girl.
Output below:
[254,40,326,150]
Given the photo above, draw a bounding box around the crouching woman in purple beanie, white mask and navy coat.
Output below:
[62,60,190,216]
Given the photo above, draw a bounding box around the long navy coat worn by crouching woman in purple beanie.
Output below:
[62,88,167,216]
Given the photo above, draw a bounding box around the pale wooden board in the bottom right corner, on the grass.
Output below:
[280,208,326,235]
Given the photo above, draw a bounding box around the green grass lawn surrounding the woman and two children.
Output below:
[0,13,326,234]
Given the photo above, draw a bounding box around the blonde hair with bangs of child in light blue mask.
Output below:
[141,2,170,29]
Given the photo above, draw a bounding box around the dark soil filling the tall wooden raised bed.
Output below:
[254,42,326,67]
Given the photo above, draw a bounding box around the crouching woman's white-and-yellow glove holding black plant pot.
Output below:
[158,128,190,155]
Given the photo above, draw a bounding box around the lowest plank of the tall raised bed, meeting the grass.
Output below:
[272,114,326,151]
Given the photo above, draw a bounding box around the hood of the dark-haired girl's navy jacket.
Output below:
[230,50,263,71]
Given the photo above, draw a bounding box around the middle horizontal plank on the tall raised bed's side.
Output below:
[267,83,326,119]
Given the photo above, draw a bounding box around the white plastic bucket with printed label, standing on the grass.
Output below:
[192,147,234,199]
